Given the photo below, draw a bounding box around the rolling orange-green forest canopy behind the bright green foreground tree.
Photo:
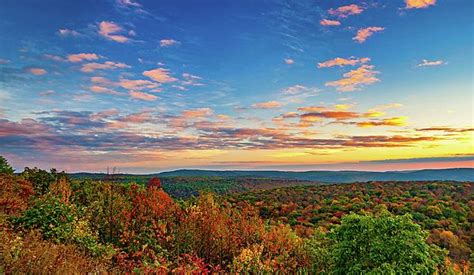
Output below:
[228,182,474,270]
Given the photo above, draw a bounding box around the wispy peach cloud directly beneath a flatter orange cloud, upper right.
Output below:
[326,64,380,92]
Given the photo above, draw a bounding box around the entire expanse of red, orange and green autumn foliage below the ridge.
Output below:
[0,158,474,274]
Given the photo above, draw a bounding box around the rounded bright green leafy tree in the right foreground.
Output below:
[329,212,441,274]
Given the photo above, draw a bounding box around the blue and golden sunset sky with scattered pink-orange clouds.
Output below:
[0,0,474,173]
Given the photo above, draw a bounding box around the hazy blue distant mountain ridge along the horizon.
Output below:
[154,168,474,183]
